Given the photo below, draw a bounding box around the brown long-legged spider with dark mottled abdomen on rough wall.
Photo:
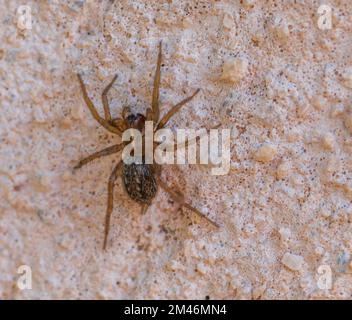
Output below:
[74,42,218,250]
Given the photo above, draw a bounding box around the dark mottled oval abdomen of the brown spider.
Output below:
[122,163,157,204]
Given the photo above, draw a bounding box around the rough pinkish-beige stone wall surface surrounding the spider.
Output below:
[0,0,352,299]
